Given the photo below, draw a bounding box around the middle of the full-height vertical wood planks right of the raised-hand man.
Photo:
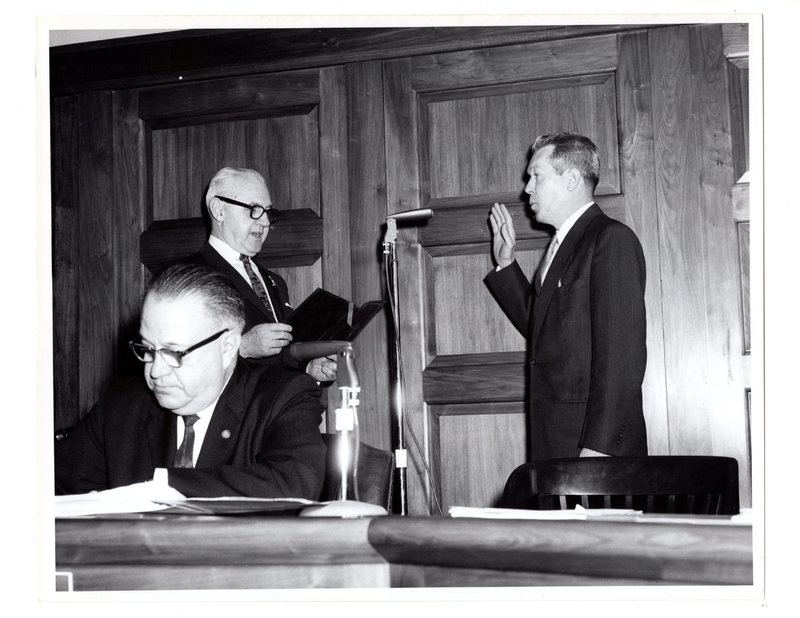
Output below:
[649,27,714,455]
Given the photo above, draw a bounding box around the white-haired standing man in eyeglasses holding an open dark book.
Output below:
[188,167,336,382]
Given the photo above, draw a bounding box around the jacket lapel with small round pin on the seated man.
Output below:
[195,359,246,468]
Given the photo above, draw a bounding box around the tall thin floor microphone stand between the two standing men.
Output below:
[383,218,408,515]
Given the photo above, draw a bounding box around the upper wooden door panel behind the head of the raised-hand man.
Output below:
[419,73,620,202]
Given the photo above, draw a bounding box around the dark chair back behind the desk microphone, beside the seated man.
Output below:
[320,433,394,511]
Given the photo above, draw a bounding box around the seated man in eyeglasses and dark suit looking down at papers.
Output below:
[55,264,325,500]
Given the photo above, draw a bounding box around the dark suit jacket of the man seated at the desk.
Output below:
[55,358,325,500]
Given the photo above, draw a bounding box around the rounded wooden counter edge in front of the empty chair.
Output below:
[369,517,753,585]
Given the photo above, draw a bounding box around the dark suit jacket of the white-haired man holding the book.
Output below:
[186,241,293,332]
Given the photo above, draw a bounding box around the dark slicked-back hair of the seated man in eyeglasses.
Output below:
[145,264,245,332]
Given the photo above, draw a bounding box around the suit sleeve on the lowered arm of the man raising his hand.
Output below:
[580,224,647,455]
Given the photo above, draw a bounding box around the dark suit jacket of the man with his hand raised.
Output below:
[485,204,647,459]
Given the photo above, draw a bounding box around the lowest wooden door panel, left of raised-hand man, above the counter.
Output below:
[431,402,527,514]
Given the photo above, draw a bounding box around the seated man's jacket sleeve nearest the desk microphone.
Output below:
[169,374,326,500]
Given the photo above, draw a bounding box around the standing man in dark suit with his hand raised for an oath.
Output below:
[485,133,647,460]
